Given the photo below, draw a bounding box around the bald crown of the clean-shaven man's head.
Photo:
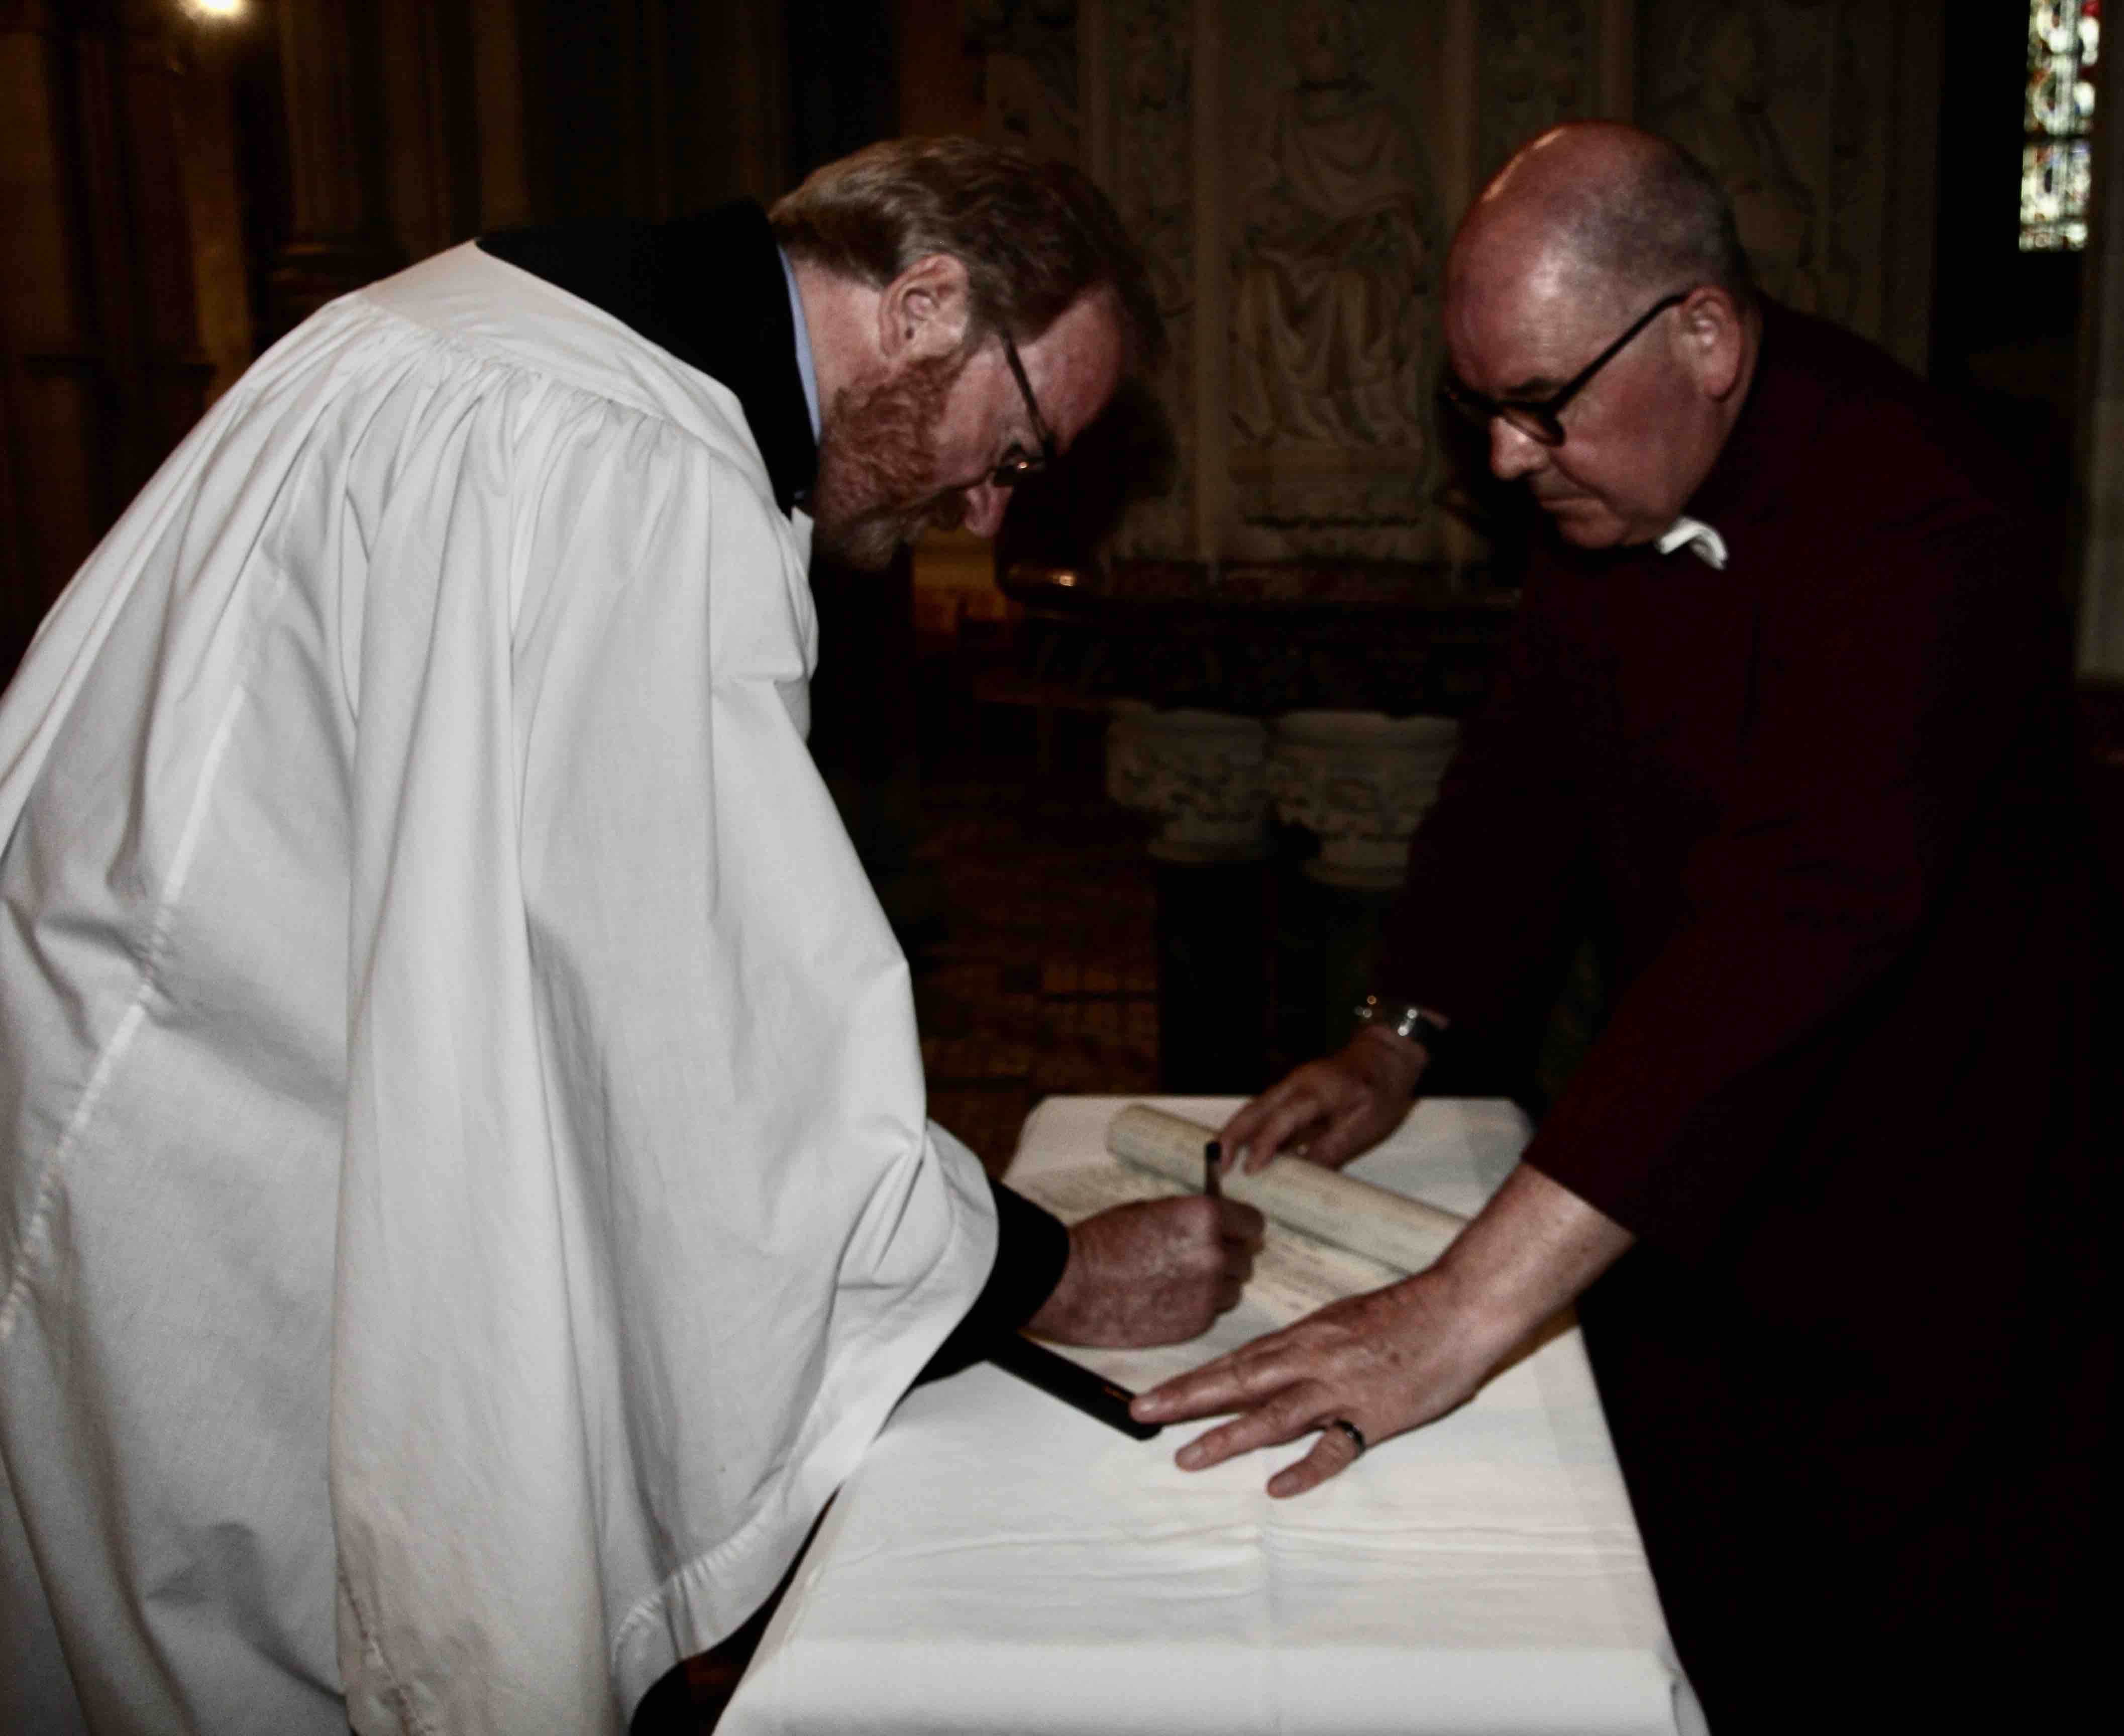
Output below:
[1446,121,1752,322]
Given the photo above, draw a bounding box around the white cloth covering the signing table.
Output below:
[720,1097,1702,1736]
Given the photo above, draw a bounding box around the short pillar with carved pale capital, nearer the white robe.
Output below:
[1107,699,1270,1095]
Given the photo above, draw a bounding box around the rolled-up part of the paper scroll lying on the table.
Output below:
[1107,1103,1468,1273]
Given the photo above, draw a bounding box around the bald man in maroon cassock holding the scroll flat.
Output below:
[1143,126,2120,1736]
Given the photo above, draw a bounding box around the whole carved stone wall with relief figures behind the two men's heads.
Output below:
[962,0,1939,567]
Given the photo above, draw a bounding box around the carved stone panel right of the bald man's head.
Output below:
[1638,0,1903,353]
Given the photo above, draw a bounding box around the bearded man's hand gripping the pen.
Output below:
[1026,1197,1266,1347]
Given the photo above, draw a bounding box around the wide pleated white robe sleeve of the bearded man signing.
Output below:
[329,376,994,1734]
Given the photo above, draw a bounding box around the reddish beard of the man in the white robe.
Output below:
[811,355,967,572]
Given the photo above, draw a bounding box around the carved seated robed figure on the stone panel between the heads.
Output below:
[1232,0,1432,446]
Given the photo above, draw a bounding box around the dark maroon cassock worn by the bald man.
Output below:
[1385,297,2124,1736]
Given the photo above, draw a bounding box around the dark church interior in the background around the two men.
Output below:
[0,0,2124,1736]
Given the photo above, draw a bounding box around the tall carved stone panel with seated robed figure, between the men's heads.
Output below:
[1219,0,1444,561]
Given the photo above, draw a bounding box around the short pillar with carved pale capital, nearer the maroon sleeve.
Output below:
[1266,712,1459,1060]
